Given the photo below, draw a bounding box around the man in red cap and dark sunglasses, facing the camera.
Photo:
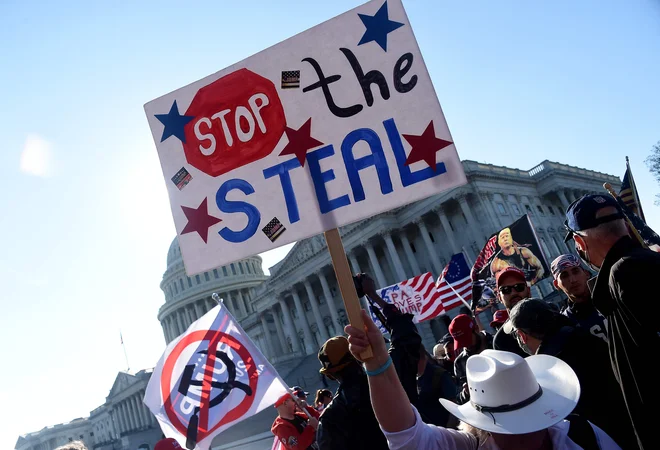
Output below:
[493,267,531,358]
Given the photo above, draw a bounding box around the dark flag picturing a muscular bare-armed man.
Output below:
[470,214,550,309]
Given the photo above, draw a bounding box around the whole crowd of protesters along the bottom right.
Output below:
[272,195,660,450]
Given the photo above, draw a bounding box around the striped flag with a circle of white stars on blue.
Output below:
[418,253,472,322]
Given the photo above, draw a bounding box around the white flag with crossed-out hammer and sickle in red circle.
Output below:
[144,298,287,450]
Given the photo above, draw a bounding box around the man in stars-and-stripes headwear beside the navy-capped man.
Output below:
[550,254,607,342]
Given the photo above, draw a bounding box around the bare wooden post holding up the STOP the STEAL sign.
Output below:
[324,228,373,360]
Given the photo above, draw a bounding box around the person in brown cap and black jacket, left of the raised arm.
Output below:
[316,336,388,450]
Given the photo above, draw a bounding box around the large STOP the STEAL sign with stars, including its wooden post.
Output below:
[145,0,466,358]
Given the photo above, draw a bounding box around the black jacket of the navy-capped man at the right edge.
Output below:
[589,237,660,450]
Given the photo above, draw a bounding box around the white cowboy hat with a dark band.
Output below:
[440,350,580,434]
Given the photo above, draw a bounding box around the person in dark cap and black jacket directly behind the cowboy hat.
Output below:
[510,299,637,449]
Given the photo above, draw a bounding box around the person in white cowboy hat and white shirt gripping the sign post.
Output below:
[346,311,620,450]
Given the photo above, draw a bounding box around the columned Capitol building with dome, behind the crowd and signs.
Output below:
[15,161,621,450]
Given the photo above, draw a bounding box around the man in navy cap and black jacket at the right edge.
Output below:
[565,195,660,449]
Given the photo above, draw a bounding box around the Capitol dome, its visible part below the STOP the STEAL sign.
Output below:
[158,238,268,344]
